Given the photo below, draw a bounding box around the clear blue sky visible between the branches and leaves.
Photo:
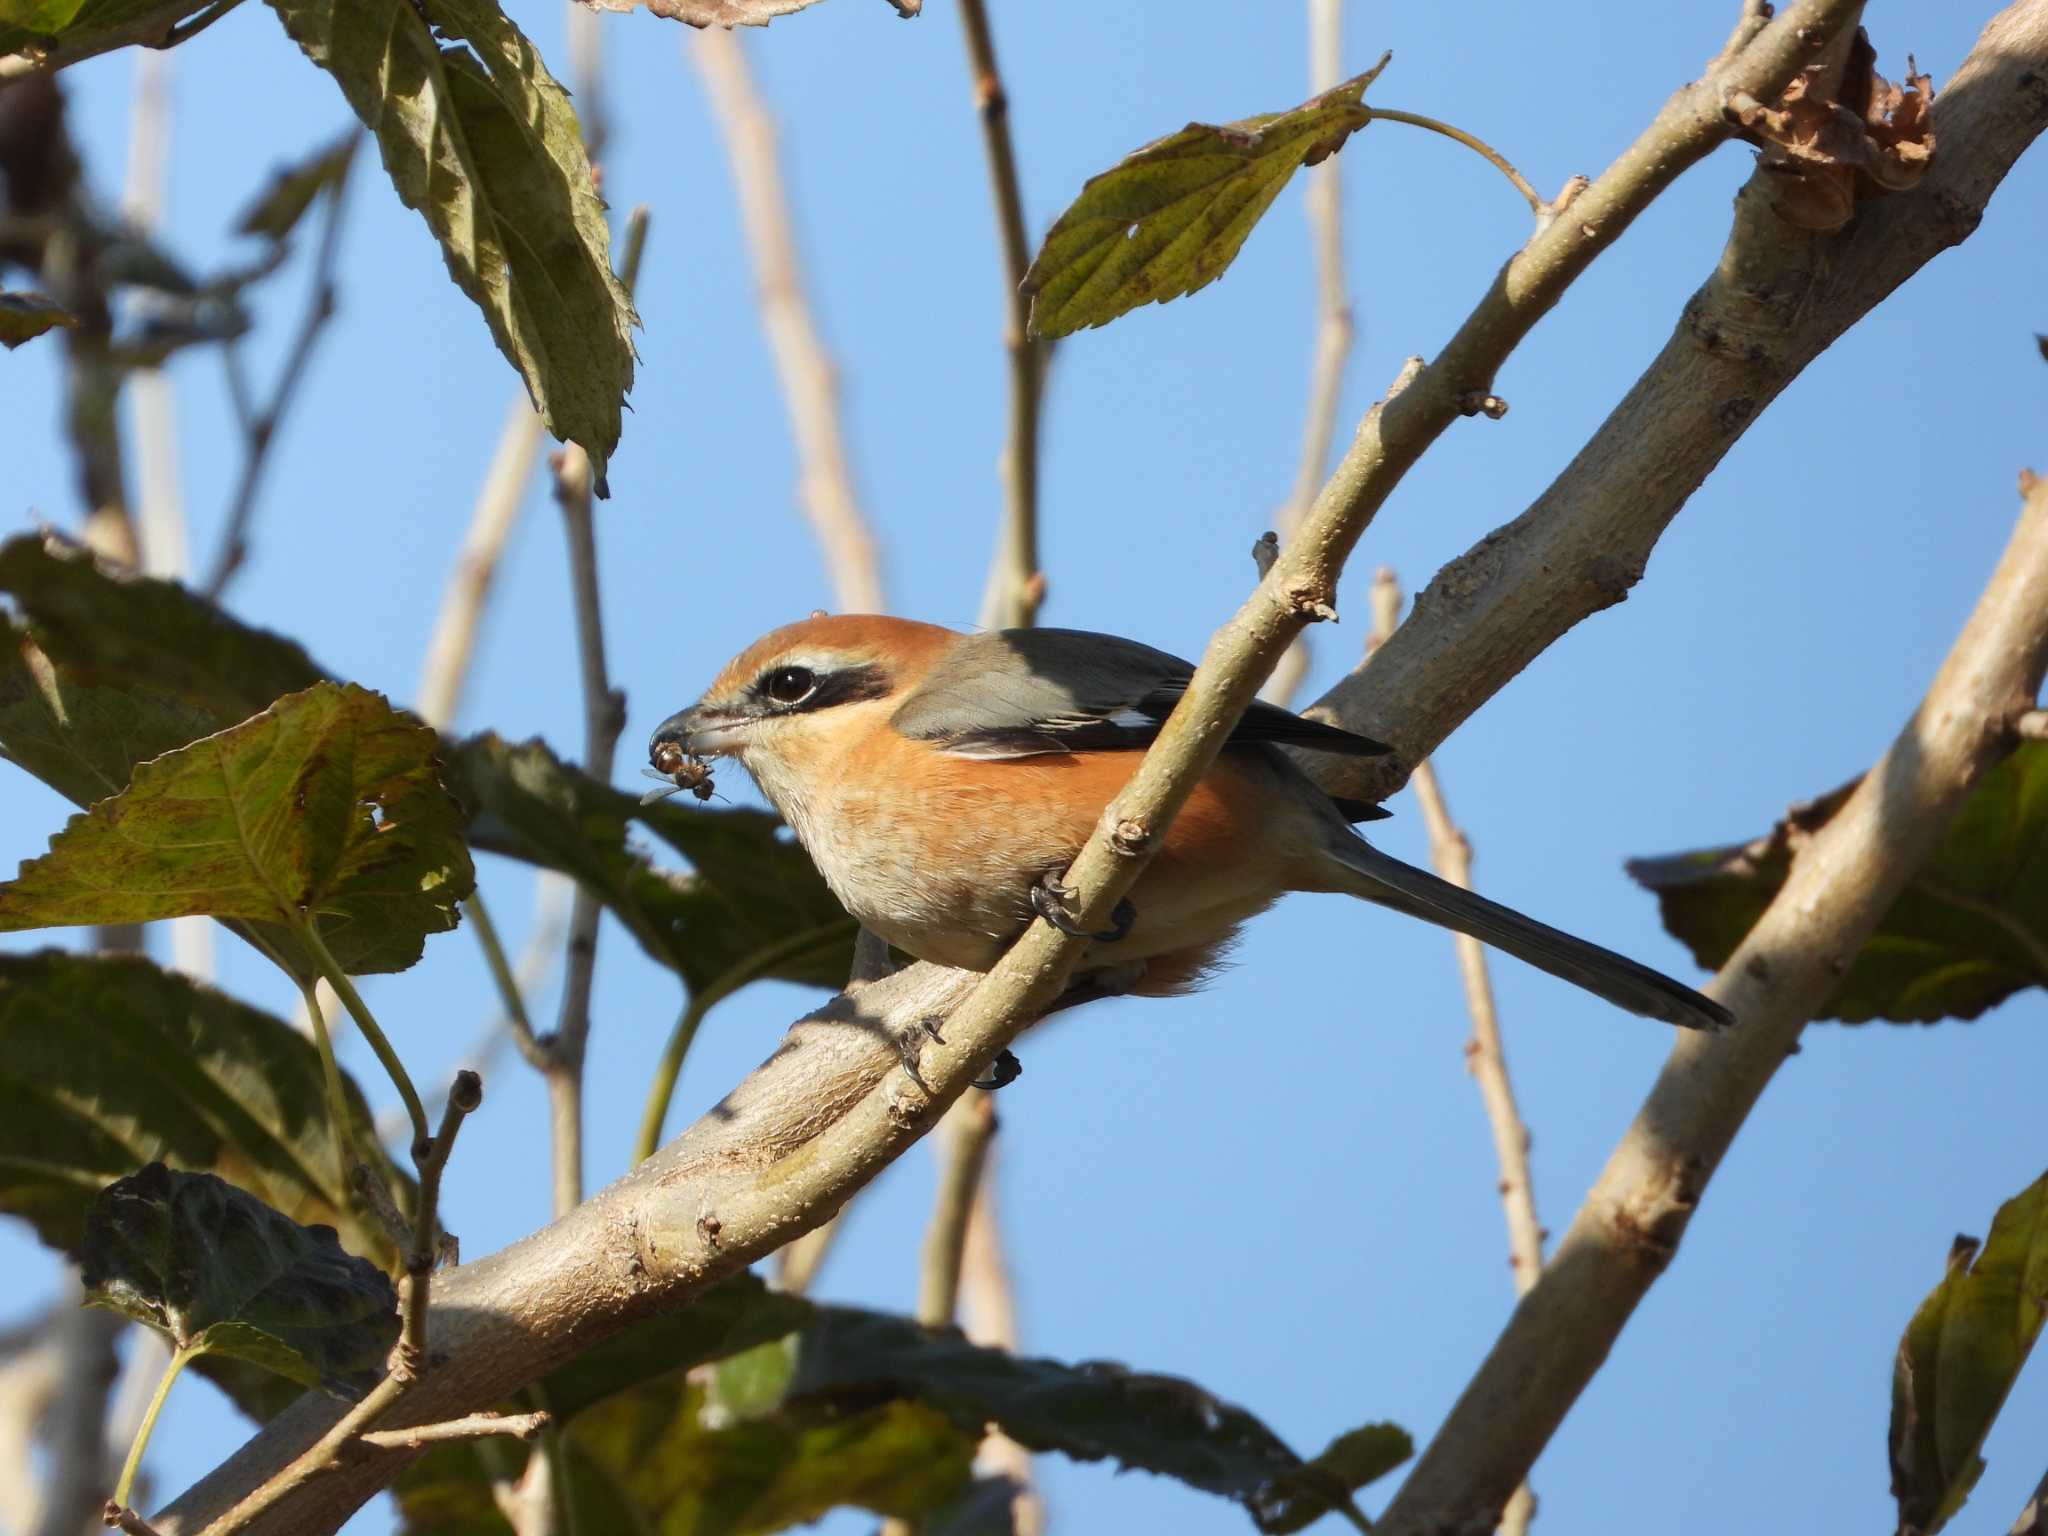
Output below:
[0,0,2048,1536]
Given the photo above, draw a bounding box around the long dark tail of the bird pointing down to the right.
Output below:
[1329,838,1735,1030]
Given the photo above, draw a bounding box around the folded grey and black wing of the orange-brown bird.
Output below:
[891,629,1389,758]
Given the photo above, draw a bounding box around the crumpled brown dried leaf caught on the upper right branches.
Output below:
[1733,29,1933,233]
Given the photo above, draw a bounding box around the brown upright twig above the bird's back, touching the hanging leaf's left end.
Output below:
[961,0,1053,629]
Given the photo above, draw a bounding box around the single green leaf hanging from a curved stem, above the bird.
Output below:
[1024,55,1391,336]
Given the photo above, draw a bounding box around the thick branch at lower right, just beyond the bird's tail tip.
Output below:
[1378,430,2048,1536]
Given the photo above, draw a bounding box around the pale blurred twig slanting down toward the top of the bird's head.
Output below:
[684,27,883,612]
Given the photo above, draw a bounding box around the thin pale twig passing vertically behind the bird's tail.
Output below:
[1372,565,1544,1536]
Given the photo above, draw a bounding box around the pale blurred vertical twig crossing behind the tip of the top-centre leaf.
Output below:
[1260,0,1354,705]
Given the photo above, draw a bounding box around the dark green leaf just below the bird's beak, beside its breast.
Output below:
[449,735,854,997]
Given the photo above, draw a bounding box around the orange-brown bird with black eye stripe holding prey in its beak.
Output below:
[647,614,1733,1030]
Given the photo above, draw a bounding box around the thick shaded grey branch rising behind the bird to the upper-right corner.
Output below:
[1311,0,2048,801]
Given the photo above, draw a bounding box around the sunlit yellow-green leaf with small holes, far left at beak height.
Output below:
[0,682,475,975]
